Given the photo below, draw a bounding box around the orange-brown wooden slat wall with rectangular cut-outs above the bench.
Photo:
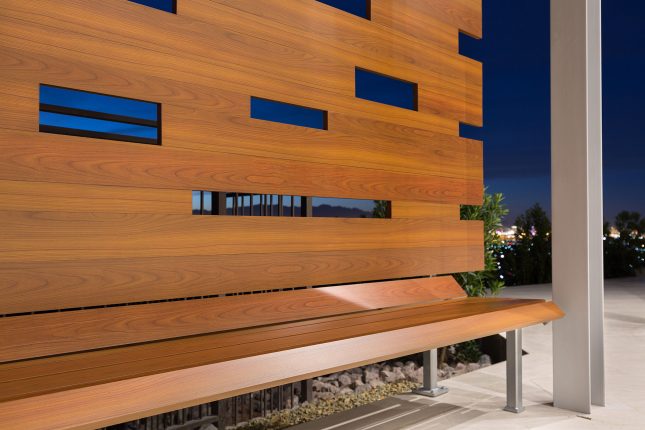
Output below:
[0,0,483,314]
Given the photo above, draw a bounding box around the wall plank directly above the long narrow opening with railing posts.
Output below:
[0,130,483,204]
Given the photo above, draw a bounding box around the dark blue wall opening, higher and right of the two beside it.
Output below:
[355,67,419,110]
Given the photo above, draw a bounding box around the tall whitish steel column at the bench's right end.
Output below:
[551,0,604,413]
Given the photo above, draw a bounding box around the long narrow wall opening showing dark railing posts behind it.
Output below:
[192,190,391,218]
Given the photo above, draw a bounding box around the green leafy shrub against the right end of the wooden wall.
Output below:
[454,189,508,297]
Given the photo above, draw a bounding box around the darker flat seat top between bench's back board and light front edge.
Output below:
[0,298,560,401]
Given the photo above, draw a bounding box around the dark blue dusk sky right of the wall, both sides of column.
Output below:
[460,0,645,225]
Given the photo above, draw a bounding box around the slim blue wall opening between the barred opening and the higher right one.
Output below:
[251,97,327,130]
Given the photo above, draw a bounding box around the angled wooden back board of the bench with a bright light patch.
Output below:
[0,277,466,362]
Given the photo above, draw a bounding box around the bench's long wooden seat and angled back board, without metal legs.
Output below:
[0,277,562,429]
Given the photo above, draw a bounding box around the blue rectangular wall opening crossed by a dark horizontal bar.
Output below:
[39,84,161,145]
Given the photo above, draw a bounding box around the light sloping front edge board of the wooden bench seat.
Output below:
[0,301,562,430]
